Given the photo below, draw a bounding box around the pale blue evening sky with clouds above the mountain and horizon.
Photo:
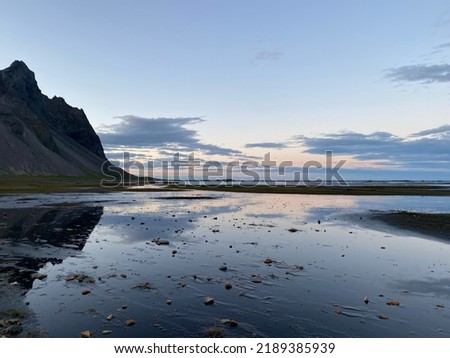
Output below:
[0,0,450,180]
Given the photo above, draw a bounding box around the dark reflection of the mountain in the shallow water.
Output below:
[0,206,103,289]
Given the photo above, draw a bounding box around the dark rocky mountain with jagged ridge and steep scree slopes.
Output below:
[0,61,110,176]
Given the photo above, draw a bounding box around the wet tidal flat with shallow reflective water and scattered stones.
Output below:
[0,190,450,337]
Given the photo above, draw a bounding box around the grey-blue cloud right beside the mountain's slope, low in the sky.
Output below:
[97,115,242,156]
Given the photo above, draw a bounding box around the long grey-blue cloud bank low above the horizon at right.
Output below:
[294,125,450,169]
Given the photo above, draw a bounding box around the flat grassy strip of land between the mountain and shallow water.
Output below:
[0,176,450,196]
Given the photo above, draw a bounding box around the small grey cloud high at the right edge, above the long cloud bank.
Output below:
[386,63,450,83]
